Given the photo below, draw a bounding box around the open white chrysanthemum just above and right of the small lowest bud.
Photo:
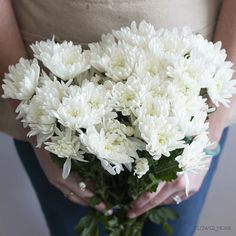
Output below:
[139,117,185,160]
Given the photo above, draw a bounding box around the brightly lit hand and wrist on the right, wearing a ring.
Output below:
[128,108,224,218]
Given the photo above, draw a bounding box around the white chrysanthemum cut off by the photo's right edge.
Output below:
[207,62,236,107]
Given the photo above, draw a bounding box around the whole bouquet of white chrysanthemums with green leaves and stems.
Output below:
[2,22,236,236]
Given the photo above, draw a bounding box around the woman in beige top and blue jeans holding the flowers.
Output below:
[0,0,236,236]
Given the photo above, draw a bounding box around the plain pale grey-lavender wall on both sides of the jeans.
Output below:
[0,125,236,236]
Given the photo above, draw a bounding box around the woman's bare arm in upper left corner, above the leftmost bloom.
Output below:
[0,0,26,79]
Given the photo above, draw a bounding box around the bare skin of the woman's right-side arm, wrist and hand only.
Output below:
[128,0,236,218]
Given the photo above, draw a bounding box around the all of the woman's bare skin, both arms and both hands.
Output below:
[0,0,236,218]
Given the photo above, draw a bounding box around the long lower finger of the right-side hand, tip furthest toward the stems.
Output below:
[128,184,176,219]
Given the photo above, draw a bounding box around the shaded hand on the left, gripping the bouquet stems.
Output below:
[32,145,105,211]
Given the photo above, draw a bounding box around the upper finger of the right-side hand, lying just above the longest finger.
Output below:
[131,182,166,208]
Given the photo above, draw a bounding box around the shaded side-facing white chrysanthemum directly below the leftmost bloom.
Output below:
[22,95,56,146]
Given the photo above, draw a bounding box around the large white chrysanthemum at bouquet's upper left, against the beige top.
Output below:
[31,38,90,80]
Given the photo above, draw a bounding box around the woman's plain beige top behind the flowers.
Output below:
[0,0,233,140]
